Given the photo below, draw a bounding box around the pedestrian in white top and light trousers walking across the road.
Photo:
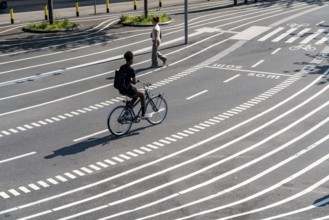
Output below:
[151,16,167,68]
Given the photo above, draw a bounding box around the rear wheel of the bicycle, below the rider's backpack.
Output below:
[107,106,133,136]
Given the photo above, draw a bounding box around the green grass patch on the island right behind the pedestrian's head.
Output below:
[120,14,171,25]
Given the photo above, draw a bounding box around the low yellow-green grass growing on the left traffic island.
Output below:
[25,18,78,31]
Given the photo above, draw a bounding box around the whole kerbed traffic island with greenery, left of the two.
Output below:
[23,19,80,33]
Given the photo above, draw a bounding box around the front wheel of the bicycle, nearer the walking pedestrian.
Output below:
[146,95,168,125]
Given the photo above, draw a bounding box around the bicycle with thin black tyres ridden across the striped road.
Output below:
[107,80,168,136]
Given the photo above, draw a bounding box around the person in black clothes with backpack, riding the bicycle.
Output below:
[114,51,150,119]
